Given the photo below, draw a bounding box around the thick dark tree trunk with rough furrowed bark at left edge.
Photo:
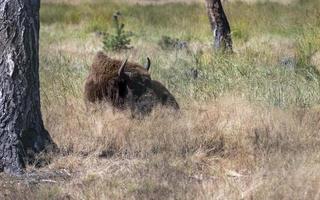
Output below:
[0,0,55,174]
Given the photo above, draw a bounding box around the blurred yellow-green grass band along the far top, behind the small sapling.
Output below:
[41,0,320,40]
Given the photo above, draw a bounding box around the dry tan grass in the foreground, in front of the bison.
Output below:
[2,96,320,199]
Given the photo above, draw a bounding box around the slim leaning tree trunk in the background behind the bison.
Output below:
[206,0,232,52]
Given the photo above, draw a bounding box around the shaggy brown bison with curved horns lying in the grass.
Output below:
[84,52,179,115]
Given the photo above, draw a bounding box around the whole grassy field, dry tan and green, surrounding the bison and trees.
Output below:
[0,0,320,200]
